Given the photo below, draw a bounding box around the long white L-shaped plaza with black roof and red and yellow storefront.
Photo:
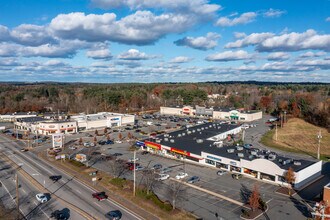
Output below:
[137,123,322,188]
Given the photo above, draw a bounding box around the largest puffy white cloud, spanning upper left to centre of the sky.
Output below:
[50,11,197,45]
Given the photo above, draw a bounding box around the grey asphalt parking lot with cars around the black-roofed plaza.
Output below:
[7,114,312,219]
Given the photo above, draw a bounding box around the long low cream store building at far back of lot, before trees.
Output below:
[160,105,262,122]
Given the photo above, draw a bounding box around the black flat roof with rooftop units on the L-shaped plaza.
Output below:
[146,123,316,172]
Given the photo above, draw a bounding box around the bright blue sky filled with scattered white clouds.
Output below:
[0,0,330,83]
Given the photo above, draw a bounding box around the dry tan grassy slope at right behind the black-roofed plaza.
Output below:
[261,118,330,156]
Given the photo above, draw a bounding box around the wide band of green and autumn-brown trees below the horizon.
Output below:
[0,81,330,128]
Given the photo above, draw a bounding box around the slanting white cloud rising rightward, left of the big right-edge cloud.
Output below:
[225,32,275,48]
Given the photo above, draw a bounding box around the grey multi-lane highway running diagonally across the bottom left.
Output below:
[0,136,142,219]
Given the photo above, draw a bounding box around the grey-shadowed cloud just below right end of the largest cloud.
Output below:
[174,32,220,50]
